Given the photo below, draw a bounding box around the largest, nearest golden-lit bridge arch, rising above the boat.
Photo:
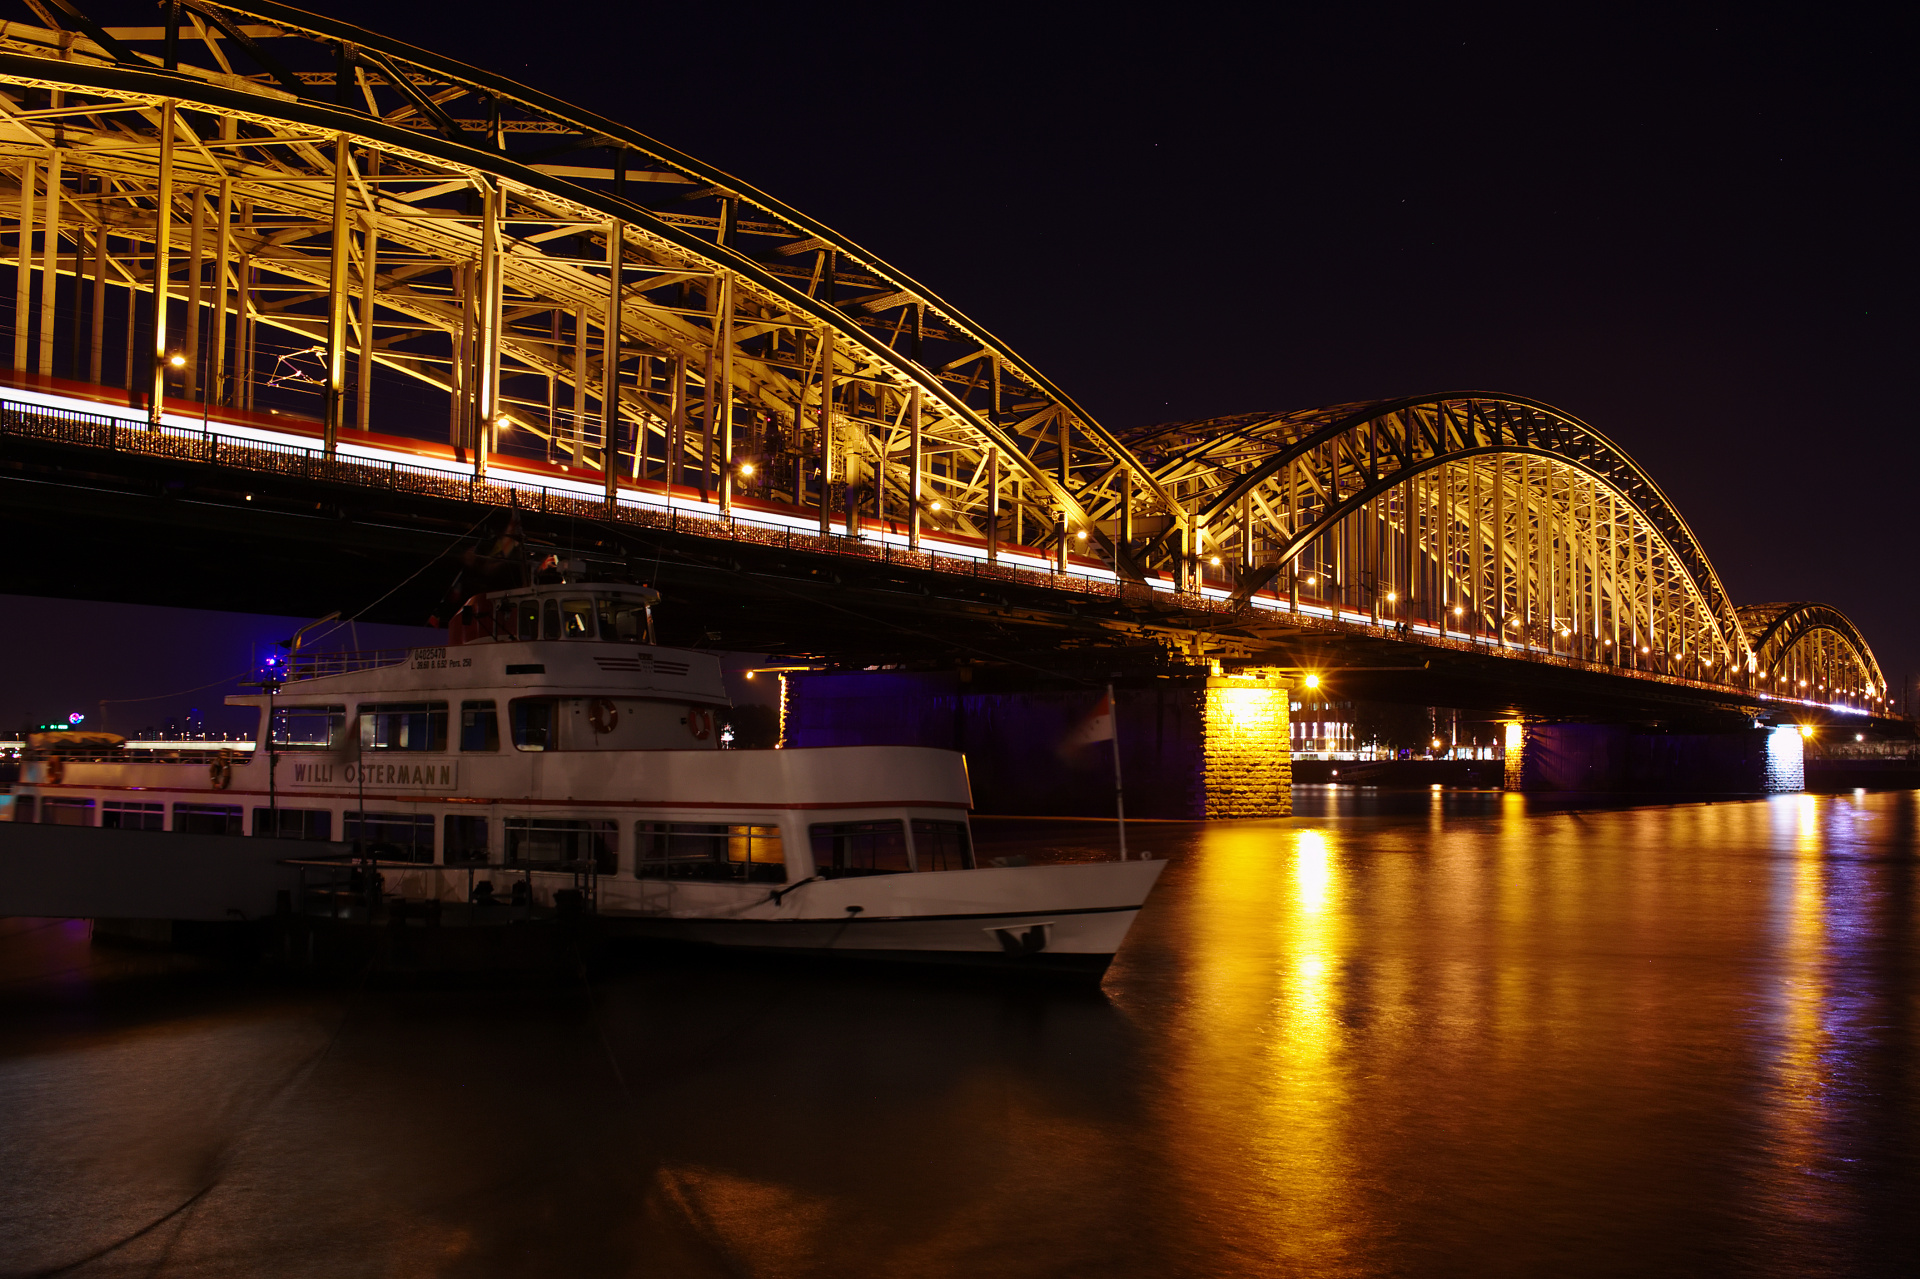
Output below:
[0,0,1173,559]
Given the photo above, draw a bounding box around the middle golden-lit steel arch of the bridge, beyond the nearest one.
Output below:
[1127,392,1753,678]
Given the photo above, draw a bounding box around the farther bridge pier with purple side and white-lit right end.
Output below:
[1505,724,1805,793]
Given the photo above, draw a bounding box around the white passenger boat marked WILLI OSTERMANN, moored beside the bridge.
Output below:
[13,580,1165,974]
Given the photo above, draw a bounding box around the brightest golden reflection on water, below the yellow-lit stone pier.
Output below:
[1177,826,1354,1273]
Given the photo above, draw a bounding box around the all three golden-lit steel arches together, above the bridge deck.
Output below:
[0,0,1885,707]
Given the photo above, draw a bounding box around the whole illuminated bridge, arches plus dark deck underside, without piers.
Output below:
[0,0,1889,806]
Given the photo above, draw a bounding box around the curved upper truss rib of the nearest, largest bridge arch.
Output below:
[0,0,1173,561]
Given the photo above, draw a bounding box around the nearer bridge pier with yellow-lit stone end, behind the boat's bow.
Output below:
[781,668,1292,818]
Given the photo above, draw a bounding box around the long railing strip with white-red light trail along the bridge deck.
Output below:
[0,391,1858,705]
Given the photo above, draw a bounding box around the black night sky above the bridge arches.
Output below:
[307,0,1920,680]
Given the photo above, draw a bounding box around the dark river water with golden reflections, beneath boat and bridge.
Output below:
[0,787,1920,1277]
